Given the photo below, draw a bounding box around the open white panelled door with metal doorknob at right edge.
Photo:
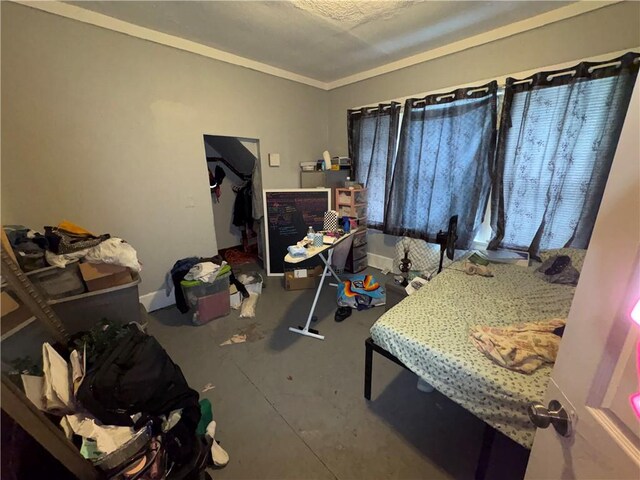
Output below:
[526,77,640,479]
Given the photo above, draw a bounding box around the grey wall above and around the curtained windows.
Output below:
[329,2,640,261]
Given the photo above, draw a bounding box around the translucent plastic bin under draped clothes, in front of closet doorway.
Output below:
[180,273,231,325]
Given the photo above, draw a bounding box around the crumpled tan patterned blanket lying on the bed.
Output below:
[470,318,565,373]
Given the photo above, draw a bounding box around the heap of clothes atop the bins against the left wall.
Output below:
[3,220,142,273]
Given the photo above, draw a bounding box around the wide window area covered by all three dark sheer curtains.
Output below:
[349,53,640,255]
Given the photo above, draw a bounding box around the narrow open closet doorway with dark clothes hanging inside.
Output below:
[204,135,264,267]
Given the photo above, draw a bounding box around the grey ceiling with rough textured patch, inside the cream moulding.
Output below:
[68,0,572,82]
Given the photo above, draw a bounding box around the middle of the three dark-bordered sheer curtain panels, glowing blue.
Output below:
[384,81,498,249]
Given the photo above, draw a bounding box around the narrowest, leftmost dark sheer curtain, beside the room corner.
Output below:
[347,102,400,229]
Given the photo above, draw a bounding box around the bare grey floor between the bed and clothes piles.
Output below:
[149,270,527,480]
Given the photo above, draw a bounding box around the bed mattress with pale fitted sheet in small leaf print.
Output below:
[371,262,575,448]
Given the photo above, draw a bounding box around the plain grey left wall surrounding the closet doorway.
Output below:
[1,2,328,294]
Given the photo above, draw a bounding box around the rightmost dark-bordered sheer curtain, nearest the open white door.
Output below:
[489,53,638,256]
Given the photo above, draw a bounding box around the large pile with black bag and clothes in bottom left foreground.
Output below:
[22,322,229,478]
